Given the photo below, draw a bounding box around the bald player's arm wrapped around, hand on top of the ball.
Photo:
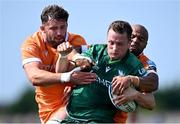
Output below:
[112,72,159,94]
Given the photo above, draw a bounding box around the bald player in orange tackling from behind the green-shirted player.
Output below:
[115,24,158,123]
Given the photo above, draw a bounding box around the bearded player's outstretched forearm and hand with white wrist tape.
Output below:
[24,62,96,86]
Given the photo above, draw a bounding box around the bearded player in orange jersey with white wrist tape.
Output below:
[21,5,96,124]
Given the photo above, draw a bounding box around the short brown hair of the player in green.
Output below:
[108,20,132,39]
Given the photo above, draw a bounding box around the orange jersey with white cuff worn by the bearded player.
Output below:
[21,31,86,123]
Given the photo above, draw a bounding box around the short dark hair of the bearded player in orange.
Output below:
[41,5,69,24]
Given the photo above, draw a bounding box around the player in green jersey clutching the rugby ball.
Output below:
[56,21,154,123]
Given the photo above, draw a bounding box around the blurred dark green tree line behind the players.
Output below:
[0,82,180,115]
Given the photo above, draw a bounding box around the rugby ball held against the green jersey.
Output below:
[108,86,137,112]
